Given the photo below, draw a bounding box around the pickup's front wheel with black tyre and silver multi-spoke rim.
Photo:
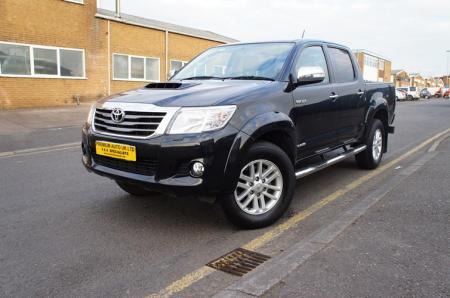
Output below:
[219,142,296,229]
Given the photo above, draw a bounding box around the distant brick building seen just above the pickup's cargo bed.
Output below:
[353,50,392,82]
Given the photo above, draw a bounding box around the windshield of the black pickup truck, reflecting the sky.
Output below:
[172,42,294,80]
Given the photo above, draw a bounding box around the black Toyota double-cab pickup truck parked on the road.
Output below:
[82,40,395,228]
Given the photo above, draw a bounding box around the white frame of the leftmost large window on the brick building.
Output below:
[0,41,87,80]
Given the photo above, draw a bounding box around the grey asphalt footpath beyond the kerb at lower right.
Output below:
[264,139,450,297]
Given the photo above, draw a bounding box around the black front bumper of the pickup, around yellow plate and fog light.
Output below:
[82,125,239,196]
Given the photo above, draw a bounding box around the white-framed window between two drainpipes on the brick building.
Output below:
[113,54,159,81]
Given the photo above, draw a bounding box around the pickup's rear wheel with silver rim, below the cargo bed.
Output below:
[355,119,386,170]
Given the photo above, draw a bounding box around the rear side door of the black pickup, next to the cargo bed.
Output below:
[327,46,365,142]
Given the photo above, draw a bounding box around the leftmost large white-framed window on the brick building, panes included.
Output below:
[0,42,85,79]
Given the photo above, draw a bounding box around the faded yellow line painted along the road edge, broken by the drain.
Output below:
[147,128,450,298]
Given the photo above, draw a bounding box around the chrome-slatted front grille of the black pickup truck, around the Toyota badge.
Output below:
[94,108,166,138]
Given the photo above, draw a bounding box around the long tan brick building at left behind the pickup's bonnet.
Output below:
[0,0,235,109]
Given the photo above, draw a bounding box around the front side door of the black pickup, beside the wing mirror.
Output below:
[291,44,334,158]
